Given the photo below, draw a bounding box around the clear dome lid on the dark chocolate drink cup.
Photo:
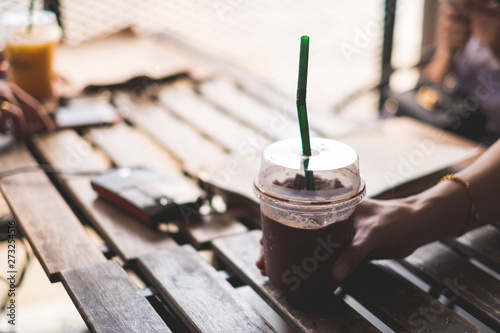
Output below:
[254,138,366,205]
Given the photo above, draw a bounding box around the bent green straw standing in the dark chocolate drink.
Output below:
[297,36,314,191]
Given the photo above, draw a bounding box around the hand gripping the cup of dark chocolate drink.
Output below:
[257,178,470,281]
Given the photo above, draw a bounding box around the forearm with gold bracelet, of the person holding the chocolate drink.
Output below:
[416,141,500,241]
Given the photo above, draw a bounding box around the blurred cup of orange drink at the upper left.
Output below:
[0,11,62,102]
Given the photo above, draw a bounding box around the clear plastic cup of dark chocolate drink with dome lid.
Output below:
[254,138,366,300]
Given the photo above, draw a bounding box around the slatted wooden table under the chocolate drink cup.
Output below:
[0,34,500,332]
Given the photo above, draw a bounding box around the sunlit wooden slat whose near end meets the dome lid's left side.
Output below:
[159,85,270,152]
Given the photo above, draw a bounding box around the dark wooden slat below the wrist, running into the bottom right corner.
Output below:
[401,243,500,328]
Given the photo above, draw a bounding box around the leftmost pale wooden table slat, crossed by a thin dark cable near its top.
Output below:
[0,145,106,282]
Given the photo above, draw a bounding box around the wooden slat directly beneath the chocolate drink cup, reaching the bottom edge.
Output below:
[212,230,378,332]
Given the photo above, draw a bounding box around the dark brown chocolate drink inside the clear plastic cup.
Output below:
[261,175,354,300]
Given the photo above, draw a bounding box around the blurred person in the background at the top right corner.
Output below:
[422,0,500,143]
